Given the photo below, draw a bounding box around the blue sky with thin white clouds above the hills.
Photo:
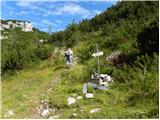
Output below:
[1,0,117,32]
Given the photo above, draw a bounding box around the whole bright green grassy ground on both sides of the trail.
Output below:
[2,45,157,118]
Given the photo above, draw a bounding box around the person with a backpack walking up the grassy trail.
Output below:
[65,48,73,66]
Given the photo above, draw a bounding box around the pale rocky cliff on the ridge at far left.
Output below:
[0,20,33,32]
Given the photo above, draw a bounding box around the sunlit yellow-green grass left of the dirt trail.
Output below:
[2,58,63,118]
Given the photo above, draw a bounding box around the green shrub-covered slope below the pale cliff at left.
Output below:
[1,26,53,75]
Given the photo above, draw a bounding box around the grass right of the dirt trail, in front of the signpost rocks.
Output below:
[49,63,156,119]
